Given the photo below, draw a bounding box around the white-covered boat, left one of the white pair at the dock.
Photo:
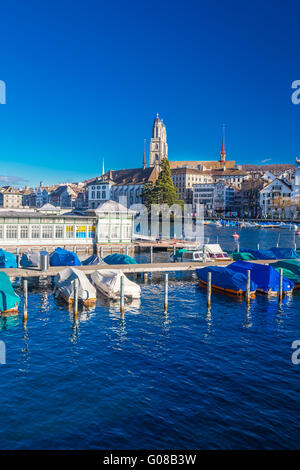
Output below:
[54,267,97,305]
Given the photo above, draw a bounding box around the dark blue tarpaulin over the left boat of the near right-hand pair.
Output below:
[196,266,257,292]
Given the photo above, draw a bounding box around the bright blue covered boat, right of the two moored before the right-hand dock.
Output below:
[228,261,294,295]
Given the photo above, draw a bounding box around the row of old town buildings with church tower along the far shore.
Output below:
[0,115,300,218]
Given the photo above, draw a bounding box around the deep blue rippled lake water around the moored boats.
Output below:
[0,228,300,449]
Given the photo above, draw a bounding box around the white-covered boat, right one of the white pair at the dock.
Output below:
[91,269,141,299]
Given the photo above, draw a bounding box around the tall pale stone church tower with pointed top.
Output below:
[150,113,168,170]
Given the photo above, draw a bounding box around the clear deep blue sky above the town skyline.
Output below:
[0,0,300,185]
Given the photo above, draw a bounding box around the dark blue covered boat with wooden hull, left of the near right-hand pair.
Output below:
[196,266,257,298]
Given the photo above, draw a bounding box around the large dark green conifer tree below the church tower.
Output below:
[143,158,183,209]
